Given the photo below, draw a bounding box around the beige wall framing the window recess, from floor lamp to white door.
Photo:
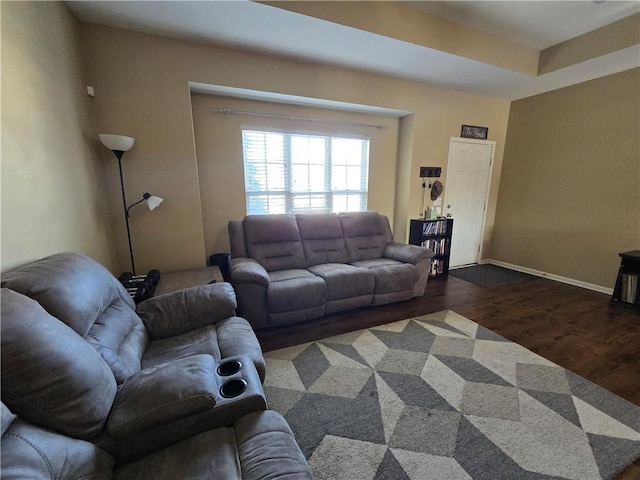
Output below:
[81,24,509,270]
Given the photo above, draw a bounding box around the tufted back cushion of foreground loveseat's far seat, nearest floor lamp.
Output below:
[2,253,149,383]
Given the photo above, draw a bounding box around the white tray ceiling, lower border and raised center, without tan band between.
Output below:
[65,0,640,100]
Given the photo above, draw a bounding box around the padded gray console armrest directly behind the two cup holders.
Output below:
[107,354,218,438]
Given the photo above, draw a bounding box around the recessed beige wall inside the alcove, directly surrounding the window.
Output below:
[192,94,399,253]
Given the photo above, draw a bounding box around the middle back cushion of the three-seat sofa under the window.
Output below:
[296,213,349,266]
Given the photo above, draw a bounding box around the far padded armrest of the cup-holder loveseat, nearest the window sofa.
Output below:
[136,282,237,340]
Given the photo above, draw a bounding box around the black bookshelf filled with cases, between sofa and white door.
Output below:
[409,218,453,278]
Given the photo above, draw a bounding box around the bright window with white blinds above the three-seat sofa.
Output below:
[242,130,369,215]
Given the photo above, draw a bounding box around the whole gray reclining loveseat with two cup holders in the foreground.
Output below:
[0,253,311,480]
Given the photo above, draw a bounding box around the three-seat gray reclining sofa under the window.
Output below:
[228,211,433,329]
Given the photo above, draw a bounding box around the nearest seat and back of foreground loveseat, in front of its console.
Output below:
[0,403,312,480]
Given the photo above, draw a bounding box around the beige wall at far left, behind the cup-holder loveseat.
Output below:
[0,2,115,271]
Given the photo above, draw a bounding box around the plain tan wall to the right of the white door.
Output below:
[490,69,640,288]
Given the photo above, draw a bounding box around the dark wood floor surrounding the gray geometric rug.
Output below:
[257,276,640,480]
